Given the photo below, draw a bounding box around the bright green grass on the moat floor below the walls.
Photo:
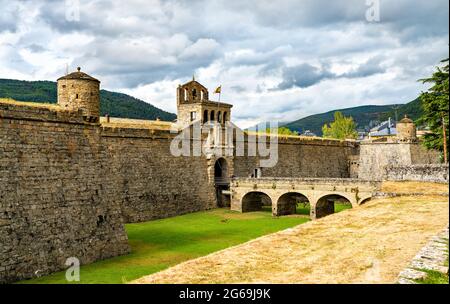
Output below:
[19,209,309,284]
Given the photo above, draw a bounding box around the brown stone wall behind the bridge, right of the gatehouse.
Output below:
[234,140,358,178]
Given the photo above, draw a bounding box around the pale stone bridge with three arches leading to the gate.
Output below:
[229,177,380,219]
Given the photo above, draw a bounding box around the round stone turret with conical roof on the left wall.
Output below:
[58,68,100,123]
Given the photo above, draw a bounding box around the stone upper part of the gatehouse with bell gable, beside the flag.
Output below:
[177,78,232,126]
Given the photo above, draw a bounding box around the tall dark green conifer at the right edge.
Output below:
[418,58,449,162]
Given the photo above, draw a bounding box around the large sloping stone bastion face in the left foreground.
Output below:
[0,105,129,282]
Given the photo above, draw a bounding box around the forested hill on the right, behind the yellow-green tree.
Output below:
[284,99,422,136]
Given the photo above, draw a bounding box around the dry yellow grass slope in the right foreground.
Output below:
[135,196,449,283]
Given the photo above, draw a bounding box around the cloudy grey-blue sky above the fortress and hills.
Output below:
[0,0,449,127]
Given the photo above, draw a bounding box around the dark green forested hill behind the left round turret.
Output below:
[0,79,177,121]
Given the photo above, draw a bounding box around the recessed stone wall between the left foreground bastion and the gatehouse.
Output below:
[102,129,217,223]
